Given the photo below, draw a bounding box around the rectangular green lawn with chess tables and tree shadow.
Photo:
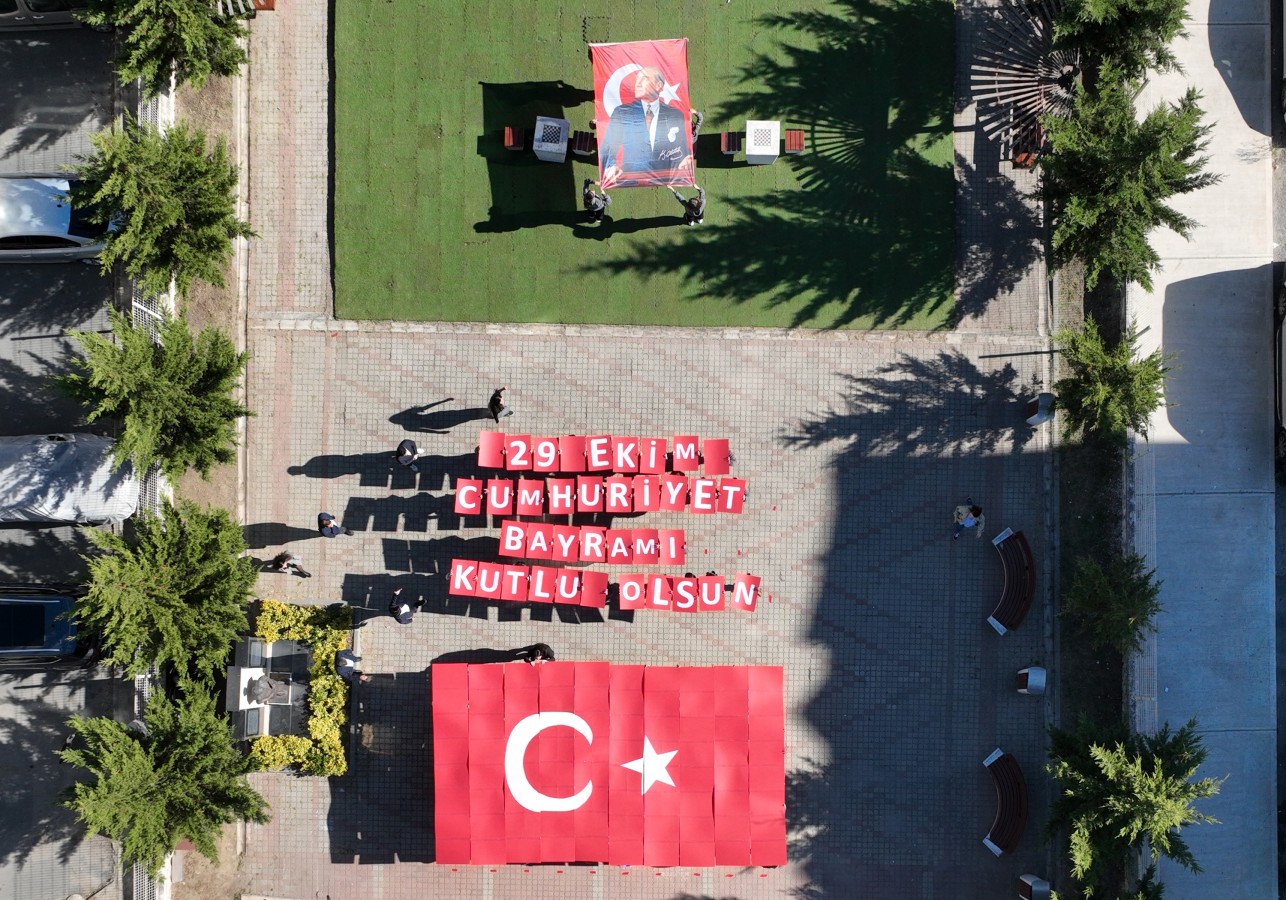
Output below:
[333,0,954,329]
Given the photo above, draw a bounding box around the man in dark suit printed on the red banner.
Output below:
[599,66,692,188]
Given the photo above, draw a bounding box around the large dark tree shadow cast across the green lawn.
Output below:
[584,0,955,328]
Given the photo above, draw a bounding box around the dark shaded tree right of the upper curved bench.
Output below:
[1060,553,1161,654]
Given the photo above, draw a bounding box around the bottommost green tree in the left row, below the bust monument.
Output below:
[59,684,269,876]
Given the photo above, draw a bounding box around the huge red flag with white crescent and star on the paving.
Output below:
[432,662,786,865]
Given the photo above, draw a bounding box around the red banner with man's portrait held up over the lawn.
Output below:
[589,37,693,190]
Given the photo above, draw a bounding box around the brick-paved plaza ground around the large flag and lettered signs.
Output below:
[236,4,1053,900]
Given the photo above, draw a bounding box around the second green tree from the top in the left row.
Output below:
[71,114,255,296]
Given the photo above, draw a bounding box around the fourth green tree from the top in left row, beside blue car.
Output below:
[73,500,257,678]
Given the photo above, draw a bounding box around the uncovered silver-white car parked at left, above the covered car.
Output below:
[0,175,107,262]
